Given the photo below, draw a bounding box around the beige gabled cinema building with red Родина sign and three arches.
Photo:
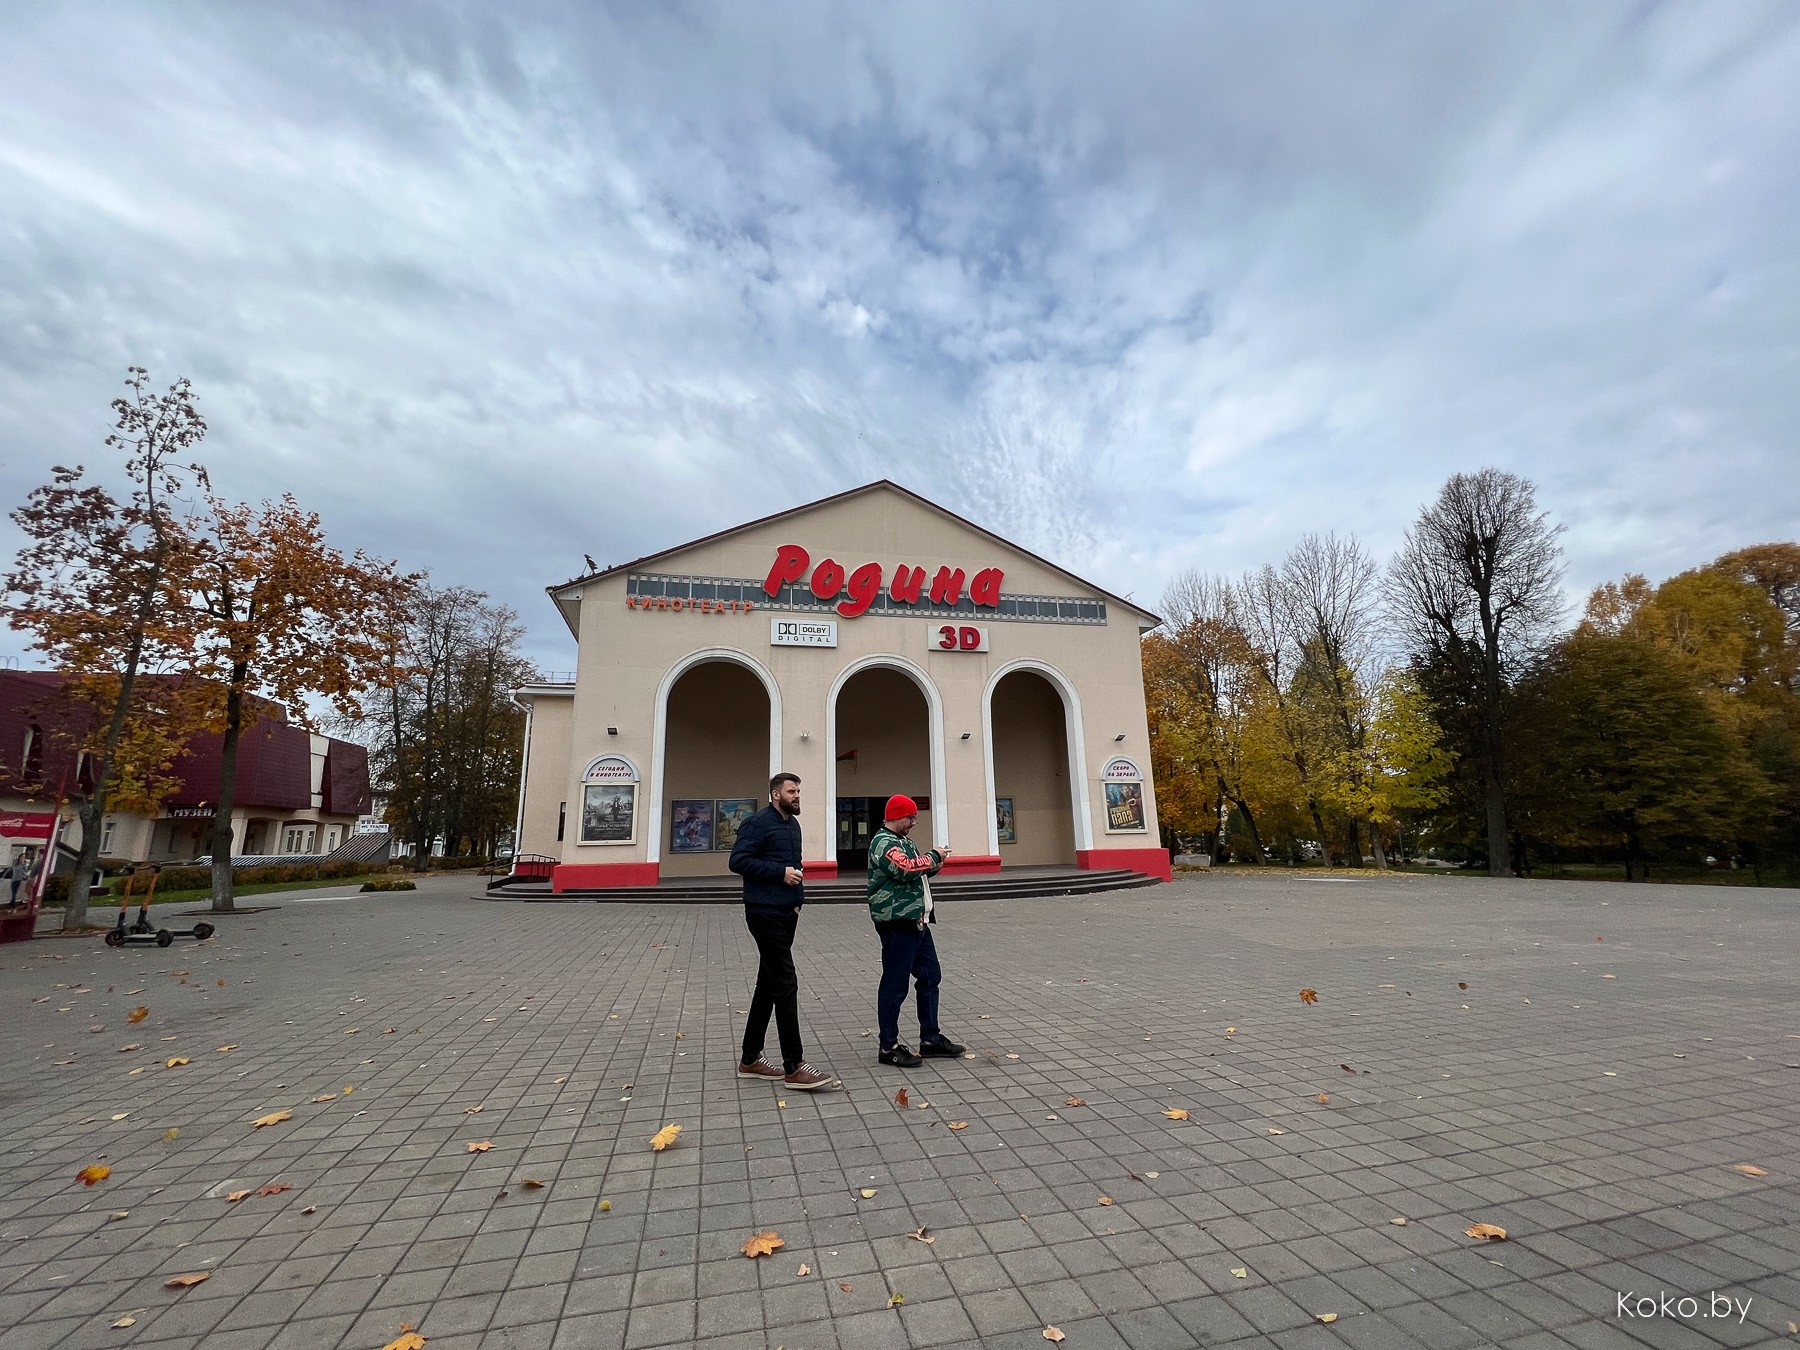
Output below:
[517,481,1170,891]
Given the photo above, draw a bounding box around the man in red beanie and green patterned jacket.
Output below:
[869,796,963,1069]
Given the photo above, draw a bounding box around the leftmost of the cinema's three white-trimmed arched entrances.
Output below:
[646,650,781,877]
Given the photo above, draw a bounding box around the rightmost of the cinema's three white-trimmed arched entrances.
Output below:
[985,661,1093,868]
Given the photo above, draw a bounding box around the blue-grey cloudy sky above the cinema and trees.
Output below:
[0,0,1800,670]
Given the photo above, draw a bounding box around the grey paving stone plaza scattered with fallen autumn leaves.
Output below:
[0,871,1800,1350]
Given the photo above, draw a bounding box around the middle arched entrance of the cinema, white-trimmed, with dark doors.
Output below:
[826,657,947,877]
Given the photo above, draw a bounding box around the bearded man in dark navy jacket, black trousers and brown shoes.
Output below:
[731,774,837,1093]
